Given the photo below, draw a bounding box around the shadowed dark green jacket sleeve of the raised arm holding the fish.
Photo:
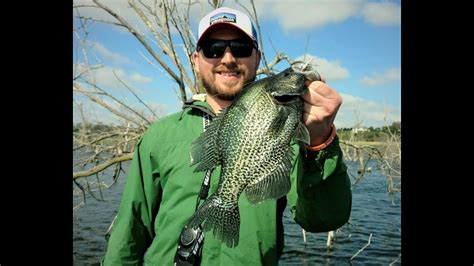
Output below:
[287,136,352,232]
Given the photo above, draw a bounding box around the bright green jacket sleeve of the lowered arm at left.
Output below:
[101,132,161,265]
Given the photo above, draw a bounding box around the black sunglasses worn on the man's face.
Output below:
[197,39,257,58]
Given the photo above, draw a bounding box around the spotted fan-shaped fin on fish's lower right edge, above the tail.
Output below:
[245,148,293,204]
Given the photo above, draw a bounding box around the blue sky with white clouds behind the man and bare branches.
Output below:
[73,0,401,128]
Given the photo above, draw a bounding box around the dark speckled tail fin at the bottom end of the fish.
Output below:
[189,195,240,247]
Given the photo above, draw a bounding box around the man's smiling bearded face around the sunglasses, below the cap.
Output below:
[193,28,260,101]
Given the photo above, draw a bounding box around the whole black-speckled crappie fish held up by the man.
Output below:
[188,67,309,247]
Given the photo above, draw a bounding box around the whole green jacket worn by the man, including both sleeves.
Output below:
[102,98,352,266]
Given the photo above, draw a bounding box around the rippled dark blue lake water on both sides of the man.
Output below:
[73,159,401,265]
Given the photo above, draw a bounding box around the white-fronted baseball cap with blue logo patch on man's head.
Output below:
[197,7,258,49]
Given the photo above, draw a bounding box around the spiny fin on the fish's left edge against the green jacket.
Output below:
[189,109,226,172]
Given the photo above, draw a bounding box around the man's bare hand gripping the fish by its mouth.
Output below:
[303,79,342,146]
